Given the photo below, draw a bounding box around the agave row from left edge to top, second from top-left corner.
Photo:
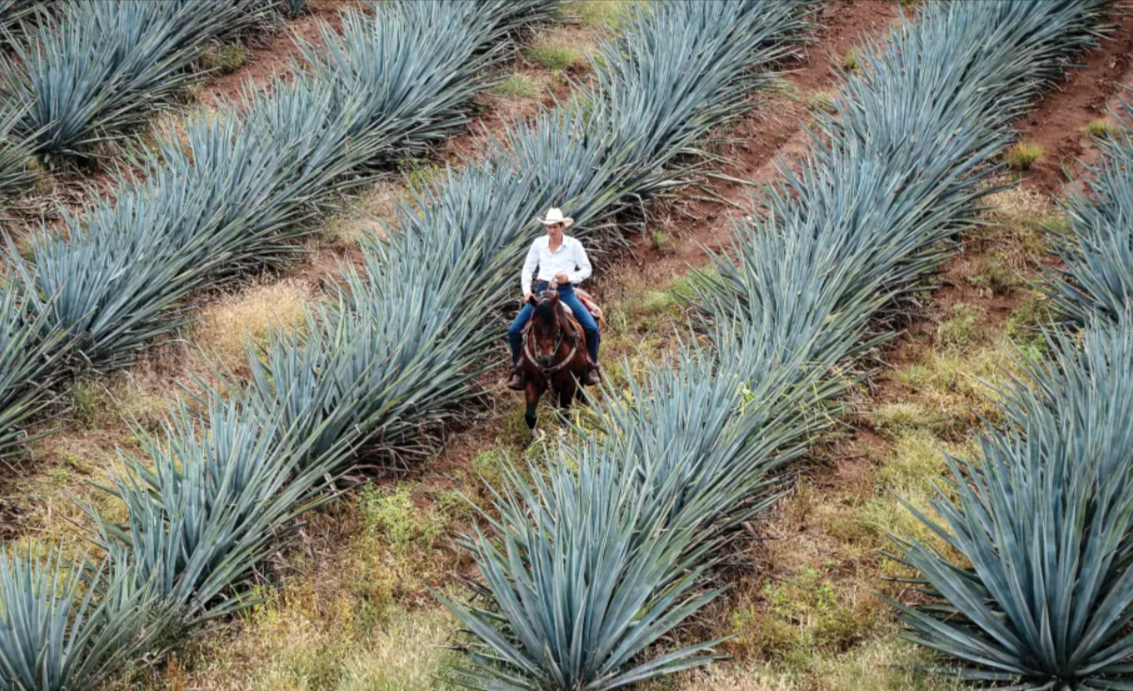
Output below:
[0,0,557,454]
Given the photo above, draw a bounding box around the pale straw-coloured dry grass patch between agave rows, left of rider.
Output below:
[194,280,310,370]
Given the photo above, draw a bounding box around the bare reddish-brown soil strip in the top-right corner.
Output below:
[1016,7,1133,195]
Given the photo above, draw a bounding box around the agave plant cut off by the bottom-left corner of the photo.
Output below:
[0,547,168,691]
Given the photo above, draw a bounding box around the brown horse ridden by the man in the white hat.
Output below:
[520,290,589,437]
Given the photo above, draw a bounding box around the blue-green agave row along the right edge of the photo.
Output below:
[898,96,1133,691]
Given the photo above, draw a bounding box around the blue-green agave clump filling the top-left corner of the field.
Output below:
[0,0,271,160]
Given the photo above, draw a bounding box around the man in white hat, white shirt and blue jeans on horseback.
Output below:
[508,203,602,391]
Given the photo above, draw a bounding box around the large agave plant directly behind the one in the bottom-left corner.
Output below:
[88,389,344,623]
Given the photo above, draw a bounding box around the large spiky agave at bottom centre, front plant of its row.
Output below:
[441,442,718,691]
